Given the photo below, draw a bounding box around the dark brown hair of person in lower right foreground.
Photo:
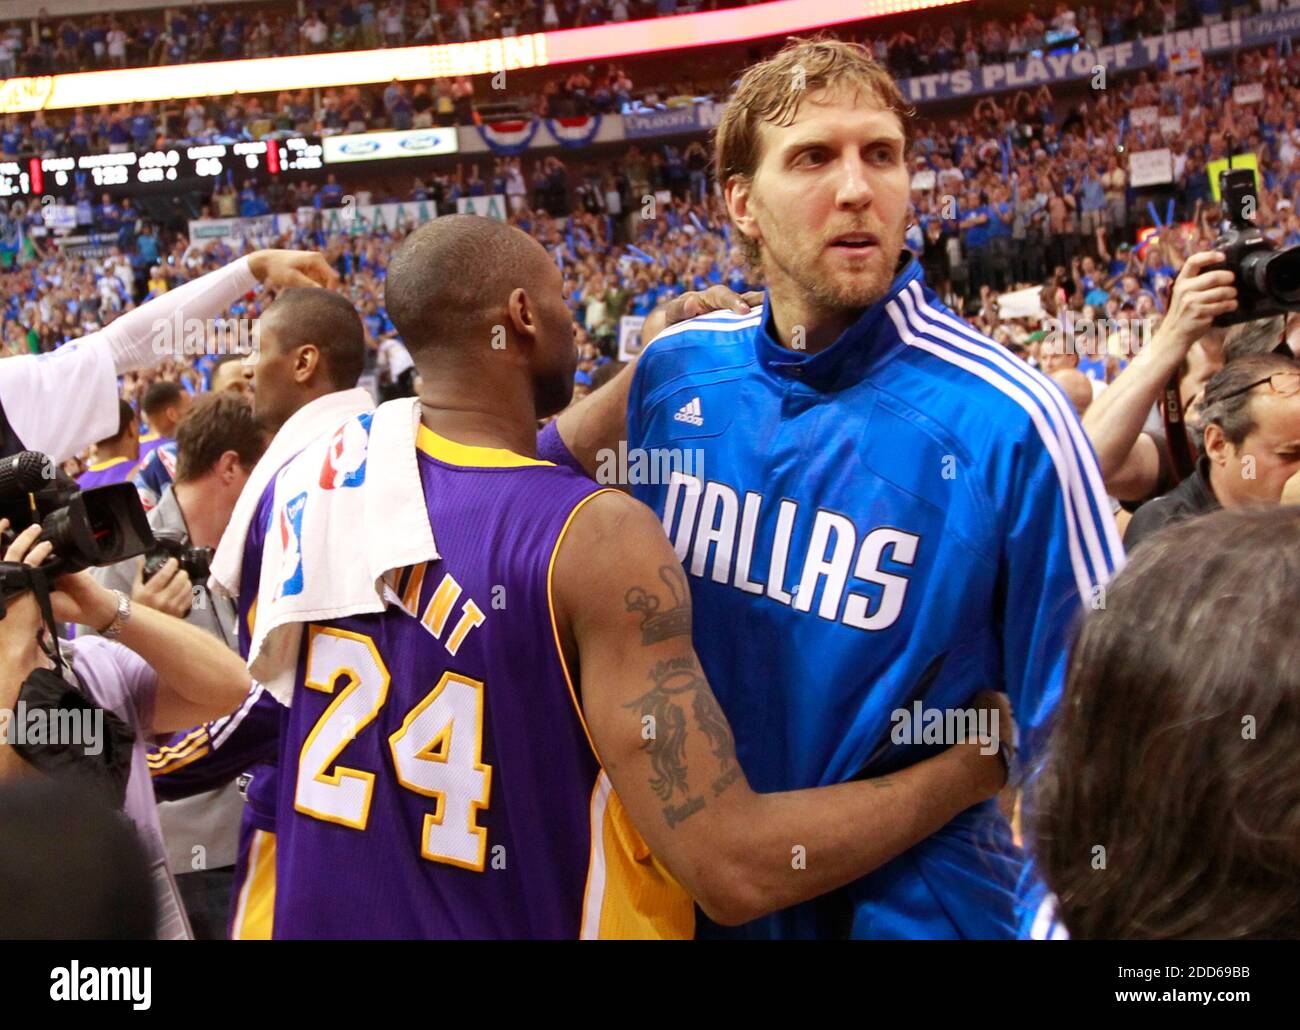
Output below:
[1026,506,1300,940]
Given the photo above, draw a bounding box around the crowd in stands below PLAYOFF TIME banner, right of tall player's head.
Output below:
[910,48,1300,316]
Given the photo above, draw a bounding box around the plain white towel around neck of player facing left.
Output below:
[211,388,374,597]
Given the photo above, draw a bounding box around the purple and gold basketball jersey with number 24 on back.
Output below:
[254,428,694,938]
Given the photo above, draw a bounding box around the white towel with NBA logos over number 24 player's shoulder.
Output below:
[248,398,438,705]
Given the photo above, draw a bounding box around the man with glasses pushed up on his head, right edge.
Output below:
[1125,354,1300,550]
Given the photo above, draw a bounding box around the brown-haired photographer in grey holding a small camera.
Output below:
[92,391,267,939]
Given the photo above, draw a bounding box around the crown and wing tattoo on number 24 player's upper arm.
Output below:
[625,566,740,827]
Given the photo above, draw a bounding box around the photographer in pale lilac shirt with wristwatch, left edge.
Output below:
[0,520,251,938]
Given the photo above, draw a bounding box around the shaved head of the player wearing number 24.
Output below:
[384,215,577,417]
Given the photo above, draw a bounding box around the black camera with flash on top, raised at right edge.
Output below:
[1212,168,1300,326]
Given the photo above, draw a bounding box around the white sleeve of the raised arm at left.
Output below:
[0,258,257,462]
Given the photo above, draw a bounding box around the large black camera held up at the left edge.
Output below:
[0,451,153,576]
